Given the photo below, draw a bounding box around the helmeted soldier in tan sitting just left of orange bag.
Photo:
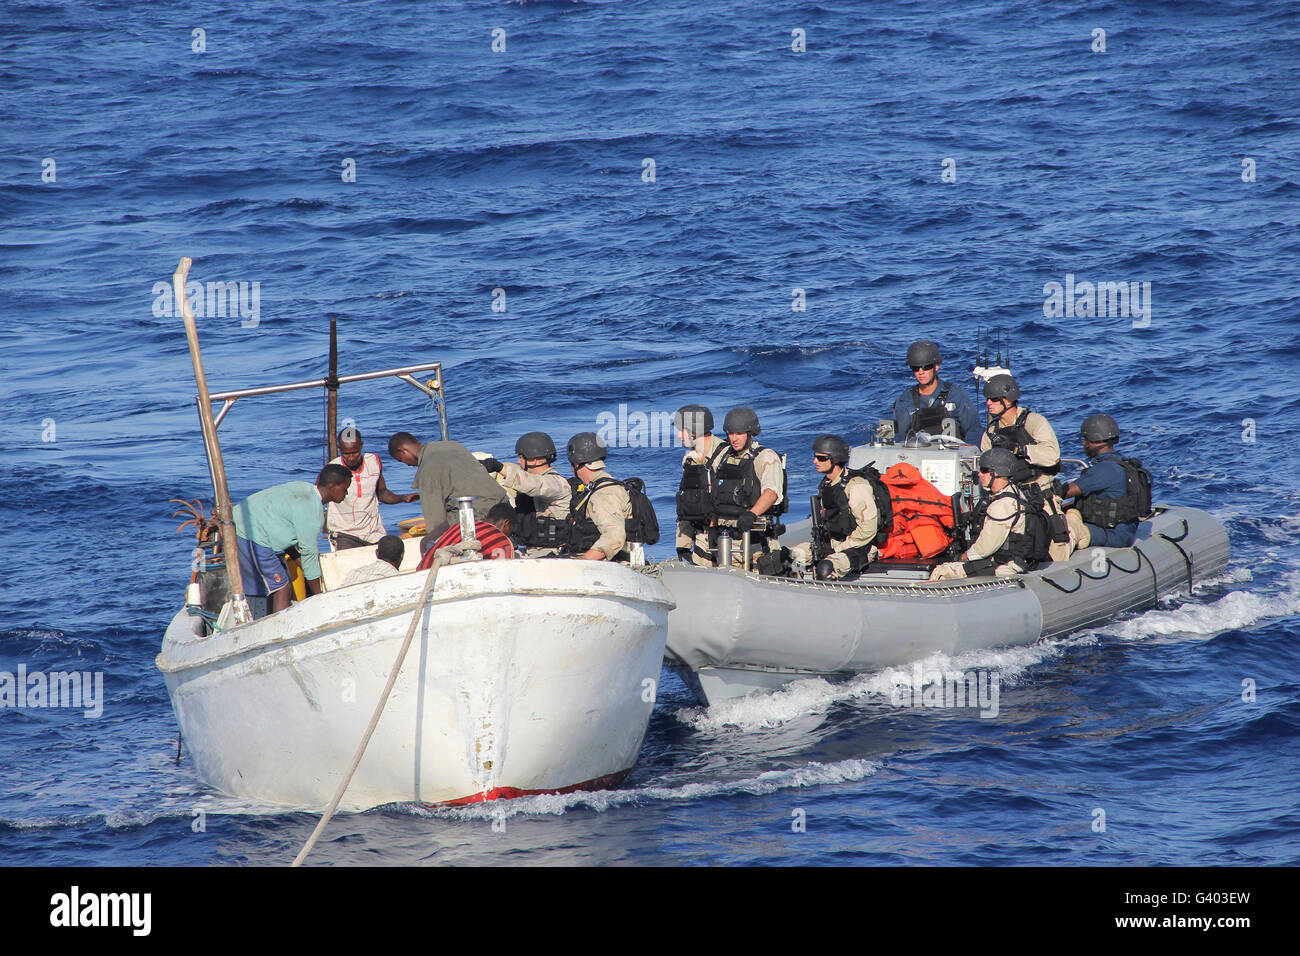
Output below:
[790,434,888,580]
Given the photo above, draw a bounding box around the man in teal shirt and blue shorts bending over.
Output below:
[234,464,352,611]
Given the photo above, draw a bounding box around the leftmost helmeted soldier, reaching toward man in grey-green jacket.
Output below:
[482,432,573,558]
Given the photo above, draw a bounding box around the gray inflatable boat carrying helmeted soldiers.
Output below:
[657,445,1229,704]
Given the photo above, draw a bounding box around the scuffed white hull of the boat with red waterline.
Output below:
[157,559,673,808]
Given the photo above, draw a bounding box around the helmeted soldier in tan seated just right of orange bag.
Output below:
[930,449,1050,581]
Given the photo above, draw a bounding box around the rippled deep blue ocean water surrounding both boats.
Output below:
[0,0,1300,865]
